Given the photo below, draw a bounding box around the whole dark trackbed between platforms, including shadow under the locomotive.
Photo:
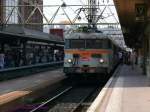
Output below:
[11,65,117,112]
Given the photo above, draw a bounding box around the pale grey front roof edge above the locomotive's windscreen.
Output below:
[65,32,108,39]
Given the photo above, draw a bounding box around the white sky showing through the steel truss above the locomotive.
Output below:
[44,0,118,23]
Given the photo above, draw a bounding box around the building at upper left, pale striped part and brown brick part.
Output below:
[0,0,43,31]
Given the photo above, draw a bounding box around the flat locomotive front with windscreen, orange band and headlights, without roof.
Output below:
[64,33,112,74]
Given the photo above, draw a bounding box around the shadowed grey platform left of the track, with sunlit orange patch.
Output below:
[0,69,65,112]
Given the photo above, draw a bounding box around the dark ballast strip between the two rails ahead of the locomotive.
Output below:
[48,87,95,112]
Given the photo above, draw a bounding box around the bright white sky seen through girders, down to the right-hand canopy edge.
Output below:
[43,0,125,46]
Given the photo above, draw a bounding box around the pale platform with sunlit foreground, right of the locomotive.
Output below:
[88,65,150,112]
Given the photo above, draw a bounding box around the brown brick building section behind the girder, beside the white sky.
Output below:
[19,0,43,31]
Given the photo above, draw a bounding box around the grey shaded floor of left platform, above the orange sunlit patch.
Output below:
[0,69,64,96]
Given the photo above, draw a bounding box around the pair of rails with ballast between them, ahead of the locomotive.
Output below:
[30,87,99,112]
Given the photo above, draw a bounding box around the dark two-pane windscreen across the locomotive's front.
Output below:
[65,39,111,49]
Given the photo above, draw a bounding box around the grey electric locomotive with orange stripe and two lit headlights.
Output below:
[64,28,118,75]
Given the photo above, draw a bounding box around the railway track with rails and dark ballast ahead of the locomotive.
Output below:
[13,80,101,112]
